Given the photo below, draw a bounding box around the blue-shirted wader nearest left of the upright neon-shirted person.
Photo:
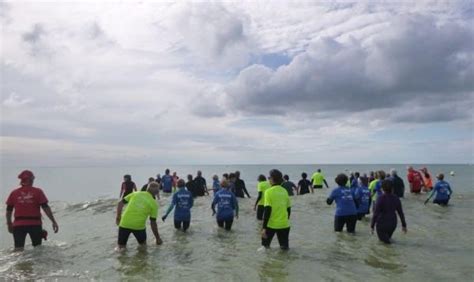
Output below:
[211,180,239,231]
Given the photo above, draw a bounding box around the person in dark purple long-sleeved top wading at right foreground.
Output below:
[370,179,407,244]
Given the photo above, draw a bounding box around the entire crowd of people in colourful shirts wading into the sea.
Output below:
[6,167,452,250]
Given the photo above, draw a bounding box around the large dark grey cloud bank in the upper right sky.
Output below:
[223,15,474,122]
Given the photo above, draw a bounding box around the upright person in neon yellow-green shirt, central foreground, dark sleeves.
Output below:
[262,169,291,250]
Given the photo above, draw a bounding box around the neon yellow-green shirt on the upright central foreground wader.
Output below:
[265,185,291,229]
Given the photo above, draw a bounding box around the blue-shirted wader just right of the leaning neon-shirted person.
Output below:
[161,179,194,232]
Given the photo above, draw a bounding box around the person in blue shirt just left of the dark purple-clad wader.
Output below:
[326,173,357,233]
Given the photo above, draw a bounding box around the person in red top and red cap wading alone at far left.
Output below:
[6,170,59,251]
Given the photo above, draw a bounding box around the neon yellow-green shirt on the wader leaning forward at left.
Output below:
[119,191,158,230]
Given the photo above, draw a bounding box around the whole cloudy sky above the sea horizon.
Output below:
[0,0,474,167]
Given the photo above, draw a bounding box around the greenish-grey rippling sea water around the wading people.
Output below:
[0,165,474,281]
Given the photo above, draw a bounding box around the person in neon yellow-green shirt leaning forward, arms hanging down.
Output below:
[115,182,163,249]
